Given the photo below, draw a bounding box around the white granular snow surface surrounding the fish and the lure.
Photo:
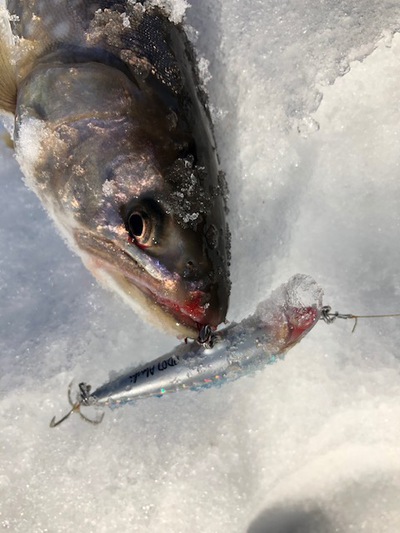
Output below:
[0,0,400,533]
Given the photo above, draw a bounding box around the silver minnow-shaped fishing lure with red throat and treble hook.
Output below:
[50,274,323,427]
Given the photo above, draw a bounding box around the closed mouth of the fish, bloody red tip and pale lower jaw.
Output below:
[75,231,227,338]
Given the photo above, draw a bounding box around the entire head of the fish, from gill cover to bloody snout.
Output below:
[16,63,230,337]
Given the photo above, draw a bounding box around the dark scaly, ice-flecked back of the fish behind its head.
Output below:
[8,0,218,171]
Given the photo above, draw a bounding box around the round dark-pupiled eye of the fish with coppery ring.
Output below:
[123,196,161,247]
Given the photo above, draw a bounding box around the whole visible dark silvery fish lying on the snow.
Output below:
[0,0,231,338]
